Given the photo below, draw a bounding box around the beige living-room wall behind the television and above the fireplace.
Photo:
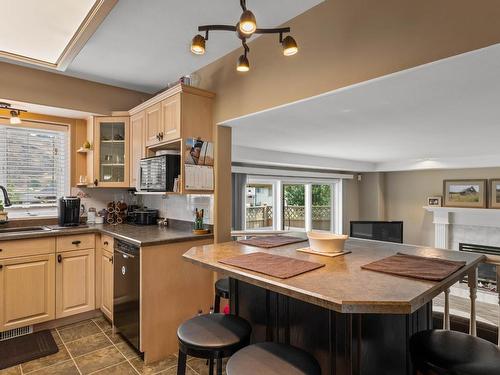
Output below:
[362,168,500,246]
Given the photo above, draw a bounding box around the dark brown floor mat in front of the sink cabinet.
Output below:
[0,330,59,370]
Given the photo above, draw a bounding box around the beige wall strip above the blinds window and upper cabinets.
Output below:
[0,62,151,115]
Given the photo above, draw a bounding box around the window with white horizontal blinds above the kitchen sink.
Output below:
[0,124,69,207]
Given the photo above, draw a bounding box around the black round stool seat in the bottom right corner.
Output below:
[410,330,500,375]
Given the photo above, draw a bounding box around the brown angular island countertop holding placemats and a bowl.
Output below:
[184,238,485,314]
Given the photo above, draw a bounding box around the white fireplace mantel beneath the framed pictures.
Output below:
[424,206,500,249]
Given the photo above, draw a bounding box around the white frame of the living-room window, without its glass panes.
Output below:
[244,175,343,234]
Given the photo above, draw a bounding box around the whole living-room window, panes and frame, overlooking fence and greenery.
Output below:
[245,176,342,233]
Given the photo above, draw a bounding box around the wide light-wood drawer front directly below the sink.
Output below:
[0,237,56,259]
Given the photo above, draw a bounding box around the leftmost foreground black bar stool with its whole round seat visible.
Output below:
[177,313,252,375]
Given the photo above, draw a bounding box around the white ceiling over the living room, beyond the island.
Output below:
[226,44,500,170]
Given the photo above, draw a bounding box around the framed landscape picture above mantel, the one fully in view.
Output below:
[443,179,488,208]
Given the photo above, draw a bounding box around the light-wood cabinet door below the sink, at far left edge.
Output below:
[0,253,55,331]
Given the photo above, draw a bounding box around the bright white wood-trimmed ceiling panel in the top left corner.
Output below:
[0,0,95,64]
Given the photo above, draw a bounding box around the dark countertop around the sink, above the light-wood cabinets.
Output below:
[0,223,213,247]
